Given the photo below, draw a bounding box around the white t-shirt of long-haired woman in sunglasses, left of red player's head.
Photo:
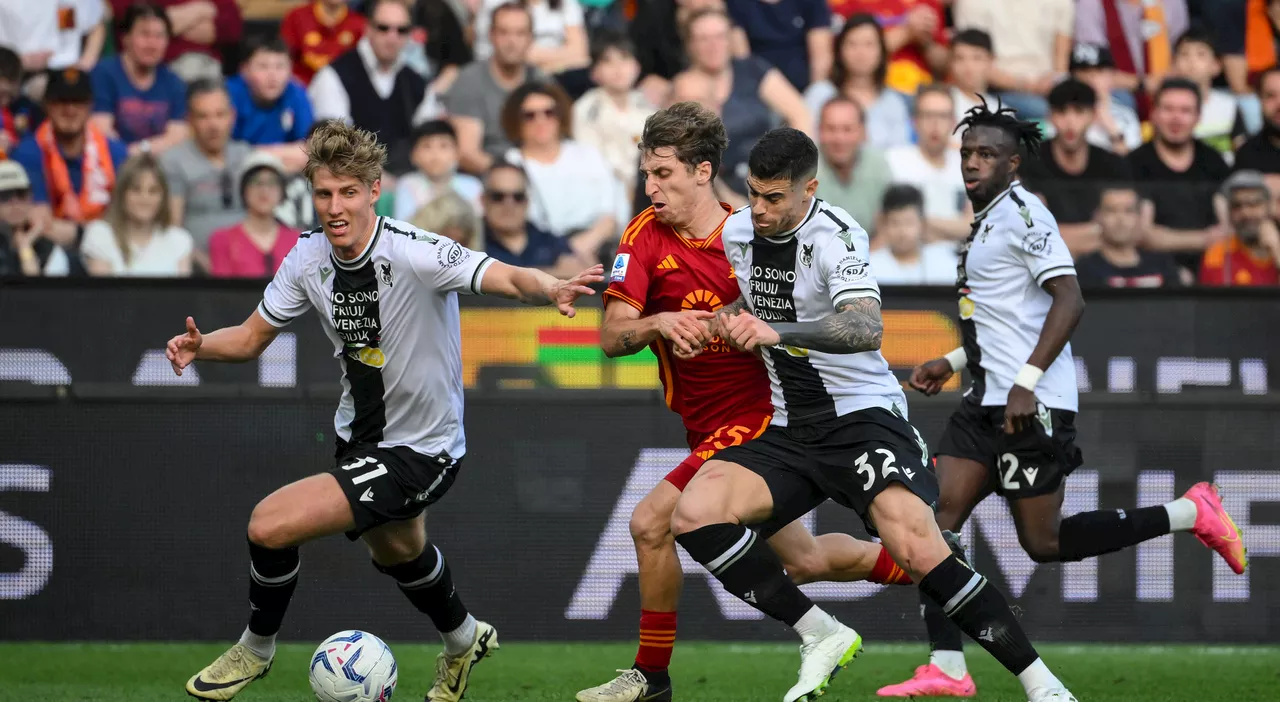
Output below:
[507,140,631,237]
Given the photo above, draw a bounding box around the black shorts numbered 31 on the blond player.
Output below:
[329,439,462,541]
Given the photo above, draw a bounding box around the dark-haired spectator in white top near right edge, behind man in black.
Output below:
[1172,24,1247,159]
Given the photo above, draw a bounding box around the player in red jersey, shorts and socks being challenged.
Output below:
[577,102,910,702]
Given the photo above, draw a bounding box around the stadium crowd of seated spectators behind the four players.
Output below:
[0,0,1280,287]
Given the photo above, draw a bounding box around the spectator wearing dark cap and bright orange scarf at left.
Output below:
[13,68,128,251]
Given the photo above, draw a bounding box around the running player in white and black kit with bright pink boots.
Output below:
[879,102,1245,697]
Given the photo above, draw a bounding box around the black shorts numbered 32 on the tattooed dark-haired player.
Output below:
[714,407,938,537]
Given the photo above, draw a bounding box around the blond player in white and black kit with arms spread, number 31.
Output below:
[168,123,603,702]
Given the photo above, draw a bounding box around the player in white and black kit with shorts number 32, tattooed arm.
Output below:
[672,128,1074,702]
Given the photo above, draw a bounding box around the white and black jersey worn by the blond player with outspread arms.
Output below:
[257,216,492,459]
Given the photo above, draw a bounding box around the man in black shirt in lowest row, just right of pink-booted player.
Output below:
[1068,181,1190,288]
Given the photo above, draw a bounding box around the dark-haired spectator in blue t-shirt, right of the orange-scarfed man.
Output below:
[93,3,187,154]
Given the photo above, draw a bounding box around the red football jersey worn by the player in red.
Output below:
[604,202,773,432]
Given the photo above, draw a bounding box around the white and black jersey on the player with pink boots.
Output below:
[956,181,1079,412]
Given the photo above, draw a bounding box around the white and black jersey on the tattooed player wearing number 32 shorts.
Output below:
[722,199,906,427]
